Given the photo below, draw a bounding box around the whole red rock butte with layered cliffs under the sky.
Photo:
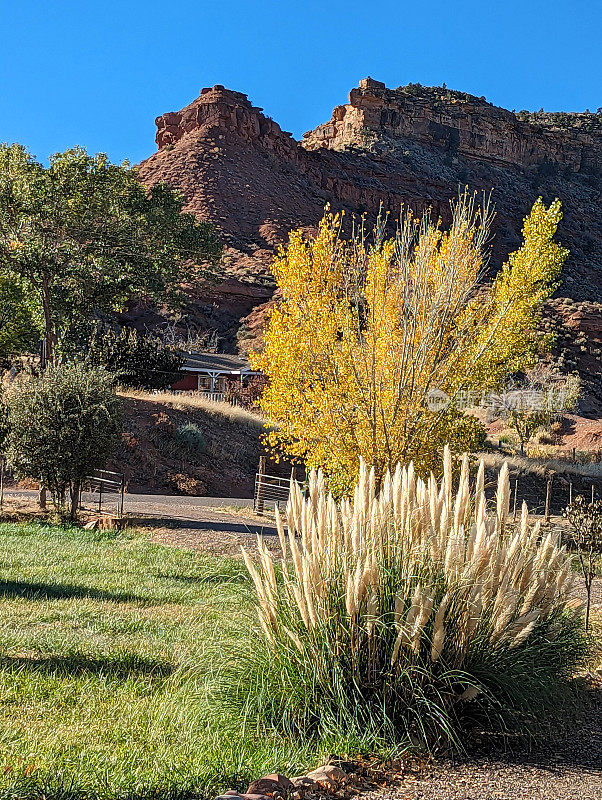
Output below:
[137,78,602,404]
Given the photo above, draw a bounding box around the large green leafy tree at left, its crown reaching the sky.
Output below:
[0,144,221,356]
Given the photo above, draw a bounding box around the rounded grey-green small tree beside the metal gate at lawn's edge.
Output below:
[6,364,121,519]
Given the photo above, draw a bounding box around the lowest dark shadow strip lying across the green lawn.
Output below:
[0,653,175,679]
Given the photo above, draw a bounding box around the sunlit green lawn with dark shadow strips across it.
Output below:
[0,524,318,800]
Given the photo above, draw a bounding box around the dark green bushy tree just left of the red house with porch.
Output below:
[87,328,184,389]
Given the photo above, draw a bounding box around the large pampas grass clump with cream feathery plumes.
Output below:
[238,450,586,747]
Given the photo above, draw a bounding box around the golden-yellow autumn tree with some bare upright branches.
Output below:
[252,195,567,493]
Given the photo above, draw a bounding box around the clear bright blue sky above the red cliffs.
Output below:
[0,0,602,162]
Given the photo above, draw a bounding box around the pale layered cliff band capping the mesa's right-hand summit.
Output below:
[303,78,602,175]
